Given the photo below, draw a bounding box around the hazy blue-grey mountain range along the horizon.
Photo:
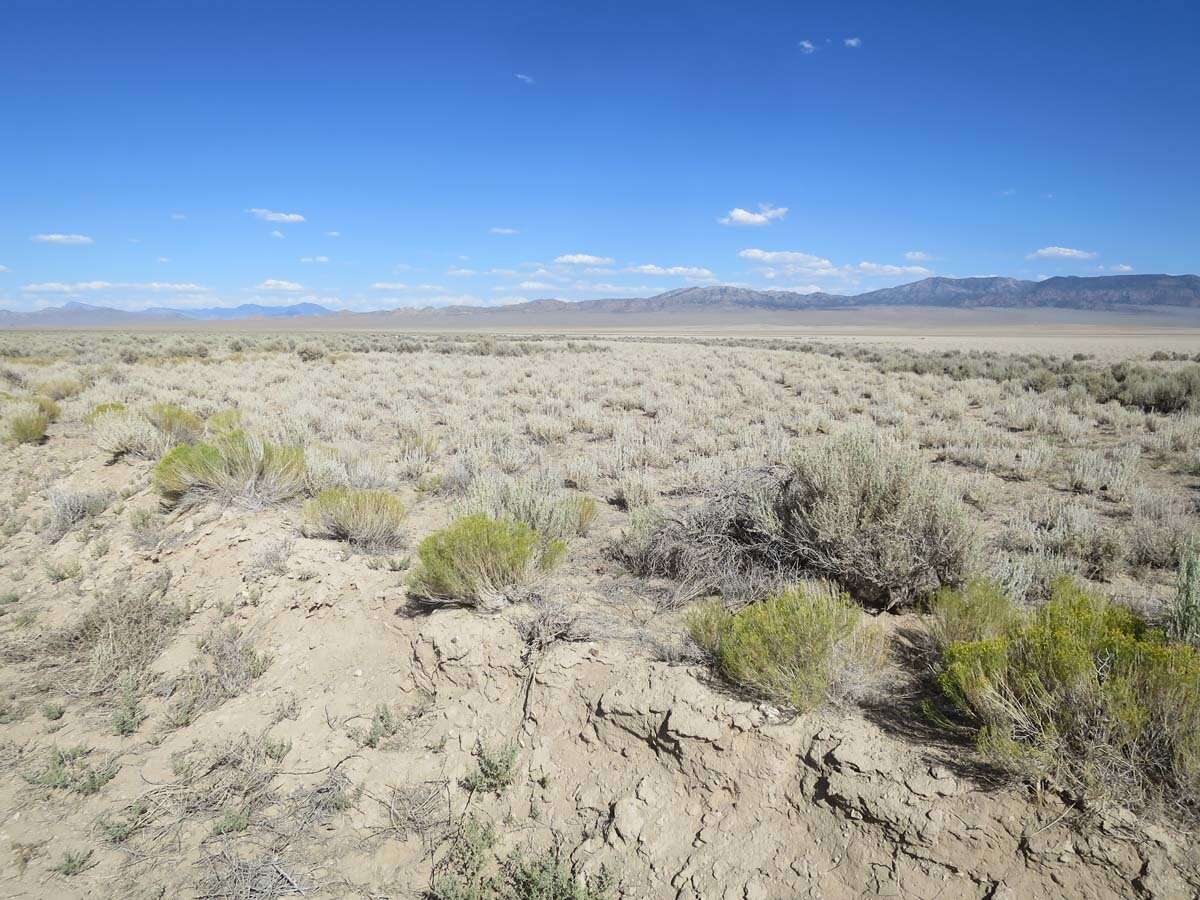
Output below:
[0,275,1200,328]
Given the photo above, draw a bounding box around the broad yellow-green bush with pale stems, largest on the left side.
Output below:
[154,431,305,508]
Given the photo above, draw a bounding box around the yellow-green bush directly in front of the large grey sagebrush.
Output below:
[688,582,886,713]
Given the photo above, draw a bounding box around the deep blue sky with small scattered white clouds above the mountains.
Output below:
[0,0,1200,310]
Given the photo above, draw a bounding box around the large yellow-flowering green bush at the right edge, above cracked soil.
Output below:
[932,578,1200,818]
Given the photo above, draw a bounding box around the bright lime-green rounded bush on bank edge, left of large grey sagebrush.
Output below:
[409,515,565,605]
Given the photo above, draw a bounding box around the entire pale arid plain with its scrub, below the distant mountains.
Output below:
[0,325,1200,900]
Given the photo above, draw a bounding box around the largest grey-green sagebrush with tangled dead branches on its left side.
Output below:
[614,430,978,608]
